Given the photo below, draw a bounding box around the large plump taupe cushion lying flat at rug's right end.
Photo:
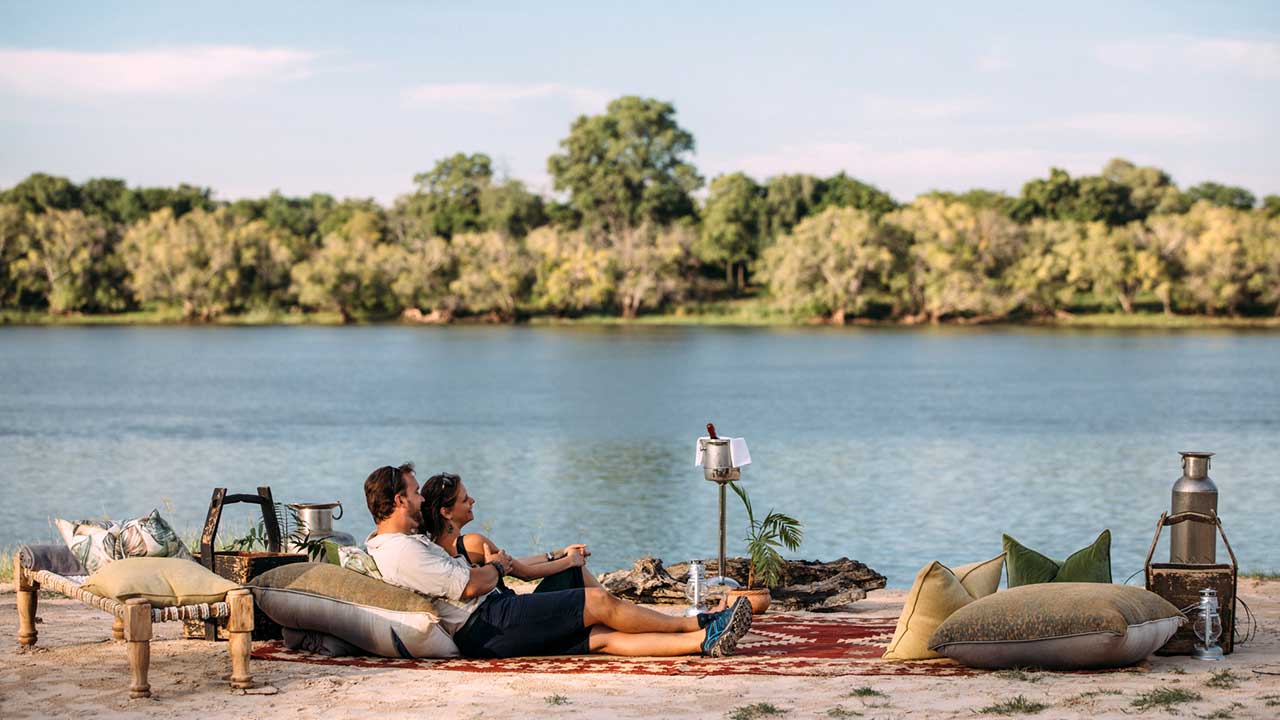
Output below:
[929,583,1185,670]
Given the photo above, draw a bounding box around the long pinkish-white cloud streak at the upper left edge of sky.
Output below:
[0,45,315,100]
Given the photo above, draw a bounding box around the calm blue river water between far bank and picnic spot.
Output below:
[0,325,1280,587]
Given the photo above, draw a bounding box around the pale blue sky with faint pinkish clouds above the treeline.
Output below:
[0,0,1280,202]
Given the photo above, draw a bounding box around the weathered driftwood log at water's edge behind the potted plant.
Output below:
[600,557,884,611]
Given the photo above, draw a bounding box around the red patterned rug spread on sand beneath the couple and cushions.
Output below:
[253,614,975,676]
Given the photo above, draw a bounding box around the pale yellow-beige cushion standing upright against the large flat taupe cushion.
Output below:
[882,555,1005,660]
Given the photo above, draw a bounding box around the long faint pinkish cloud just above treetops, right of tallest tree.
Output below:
[723,142,1108,199]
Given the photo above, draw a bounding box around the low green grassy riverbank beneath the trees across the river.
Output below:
[0,299,1280,329]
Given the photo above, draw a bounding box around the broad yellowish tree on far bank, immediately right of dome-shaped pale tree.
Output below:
[884,197,1024,323]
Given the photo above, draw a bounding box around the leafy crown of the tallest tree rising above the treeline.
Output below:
[547,96,703,231]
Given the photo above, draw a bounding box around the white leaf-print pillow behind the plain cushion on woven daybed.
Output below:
[54,510,192,574]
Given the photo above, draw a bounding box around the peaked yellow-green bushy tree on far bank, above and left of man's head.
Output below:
[292,210,406,323]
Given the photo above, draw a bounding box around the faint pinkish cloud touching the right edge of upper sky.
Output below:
[1094,35,1280,79]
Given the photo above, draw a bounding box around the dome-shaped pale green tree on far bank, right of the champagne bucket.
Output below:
[764,208,899,324]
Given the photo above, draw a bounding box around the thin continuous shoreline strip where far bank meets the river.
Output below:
[0,310,1280,331]
